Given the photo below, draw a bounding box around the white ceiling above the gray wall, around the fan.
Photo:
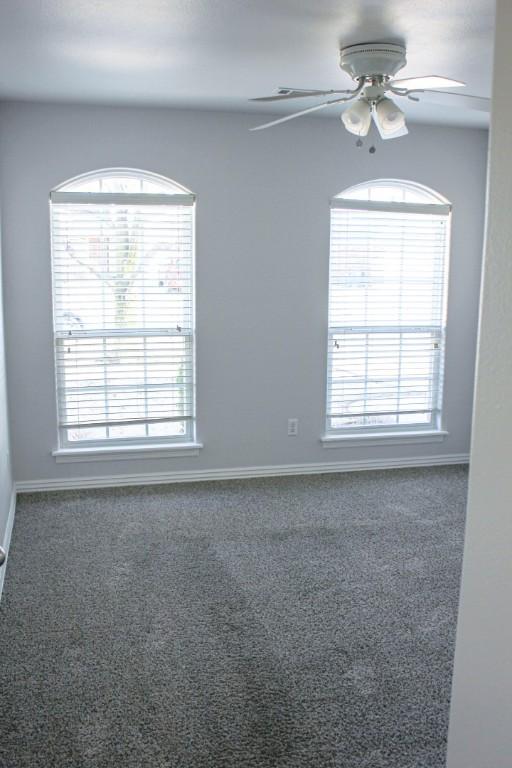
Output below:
[0,0,494,130]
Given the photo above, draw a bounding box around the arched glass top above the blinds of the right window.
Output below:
[335,179,449,206]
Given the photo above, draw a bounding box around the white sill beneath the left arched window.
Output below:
[52,443,203,464]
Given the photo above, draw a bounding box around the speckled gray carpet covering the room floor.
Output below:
[0,467,467,768]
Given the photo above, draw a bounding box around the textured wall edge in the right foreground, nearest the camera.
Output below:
[448,0,512,768]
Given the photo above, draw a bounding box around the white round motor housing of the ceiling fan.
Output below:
[340,43,407,80]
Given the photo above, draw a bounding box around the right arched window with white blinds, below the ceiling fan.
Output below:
[326,181,450,435]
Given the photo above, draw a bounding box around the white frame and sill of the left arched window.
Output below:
[49,168,198,461]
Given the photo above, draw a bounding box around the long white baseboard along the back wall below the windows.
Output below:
[16,453,469,493]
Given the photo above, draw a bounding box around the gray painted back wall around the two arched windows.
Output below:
[0,103,487,480]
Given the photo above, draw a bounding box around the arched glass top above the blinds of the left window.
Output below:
[55,168,192,195]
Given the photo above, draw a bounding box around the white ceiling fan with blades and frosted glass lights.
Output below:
[250,43,489,139]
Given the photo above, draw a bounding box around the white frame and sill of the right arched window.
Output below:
[321,179,452,440]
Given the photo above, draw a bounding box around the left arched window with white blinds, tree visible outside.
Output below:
[50,169,195,447]
